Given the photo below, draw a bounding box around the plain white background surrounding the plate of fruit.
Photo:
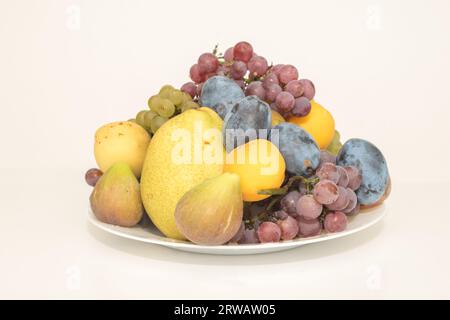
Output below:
[0,0,450,299]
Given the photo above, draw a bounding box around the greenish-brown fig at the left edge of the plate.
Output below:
[90,162,144,227]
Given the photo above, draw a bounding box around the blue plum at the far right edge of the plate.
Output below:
[337,139,389,206]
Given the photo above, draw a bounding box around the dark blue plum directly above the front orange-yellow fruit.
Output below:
[223,96,272,152]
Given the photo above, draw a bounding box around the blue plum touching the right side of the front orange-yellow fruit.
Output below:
[270,122,320,176]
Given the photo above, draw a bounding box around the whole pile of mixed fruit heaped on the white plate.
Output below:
[85,42,391,245]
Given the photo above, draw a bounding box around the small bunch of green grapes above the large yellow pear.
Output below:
[131,85,200,134]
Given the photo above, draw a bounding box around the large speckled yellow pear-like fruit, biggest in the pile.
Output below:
[141,108,225,239]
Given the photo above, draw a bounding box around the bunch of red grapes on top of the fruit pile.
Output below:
[181,41,315,117]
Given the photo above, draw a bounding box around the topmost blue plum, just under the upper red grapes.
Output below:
[199,76,245,119]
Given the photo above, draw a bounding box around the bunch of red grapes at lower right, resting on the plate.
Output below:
[232,150,362,244]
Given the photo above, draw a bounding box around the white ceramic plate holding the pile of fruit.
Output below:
[88,205,386,255]
